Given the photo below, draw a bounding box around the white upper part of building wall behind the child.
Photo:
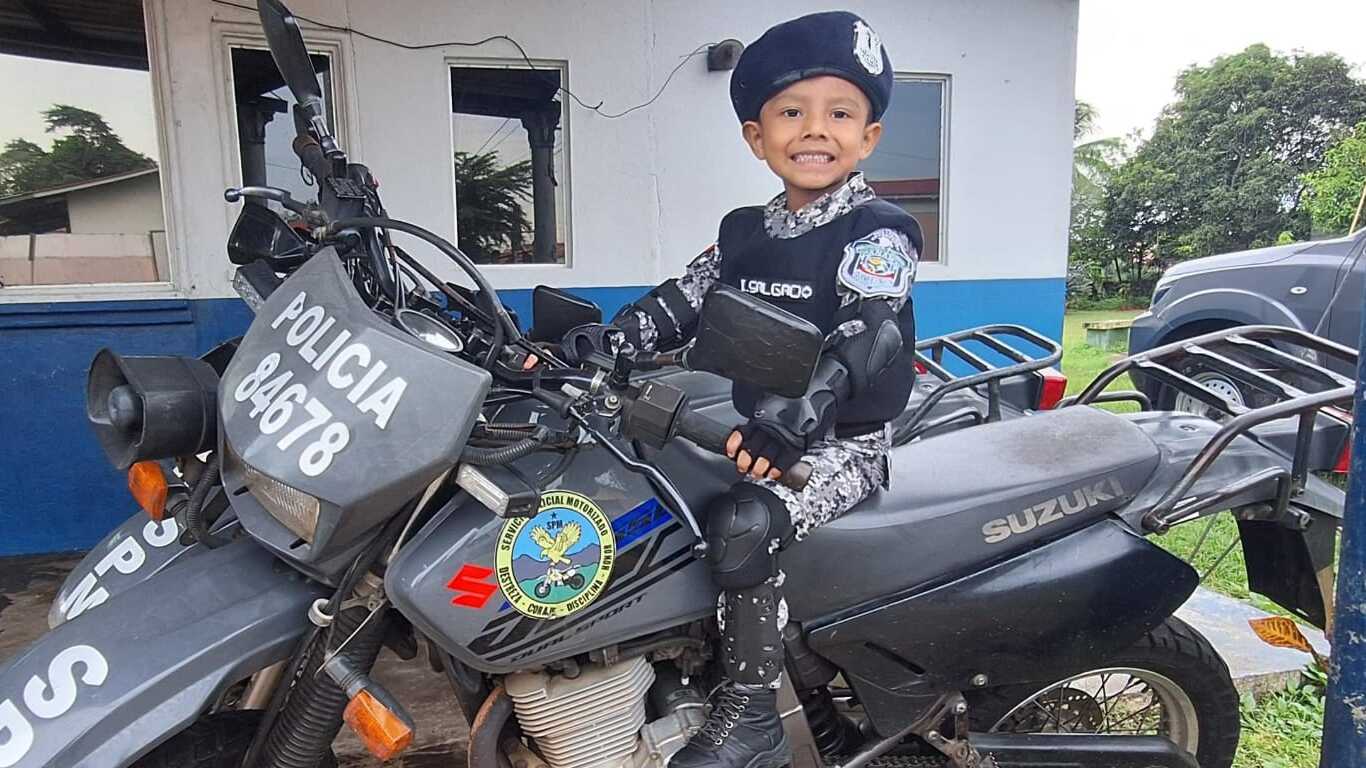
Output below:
[8,0,1078,298]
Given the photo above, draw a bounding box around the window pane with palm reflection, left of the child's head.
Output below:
[451,63,570,265]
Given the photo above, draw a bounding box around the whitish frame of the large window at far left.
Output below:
[0,0,190,305]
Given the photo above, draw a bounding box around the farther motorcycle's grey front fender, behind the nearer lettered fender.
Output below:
[48,510,238,629]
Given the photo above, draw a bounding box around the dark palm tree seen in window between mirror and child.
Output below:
[455,152,531,264]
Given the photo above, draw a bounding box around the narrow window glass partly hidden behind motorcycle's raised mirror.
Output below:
[229,45,336,219]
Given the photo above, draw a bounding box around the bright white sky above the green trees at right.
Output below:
[1076,0,1366,138]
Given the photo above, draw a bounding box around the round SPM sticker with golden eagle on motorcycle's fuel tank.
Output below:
[496,491,616,619]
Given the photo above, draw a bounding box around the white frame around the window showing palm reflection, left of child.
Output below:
[443,56,575,273]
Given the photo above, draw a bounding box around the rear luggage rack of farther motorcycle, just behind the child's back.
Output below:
[892,324,1063,445]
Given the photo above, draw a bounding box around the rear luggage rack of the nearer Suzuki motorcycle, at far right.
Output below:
[1065,325,1356,533]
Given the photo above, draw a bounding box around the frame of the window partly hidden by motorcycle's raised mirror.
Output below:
[213,22,357,232]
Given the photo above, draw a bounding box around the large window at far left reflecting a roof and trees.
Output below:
[0,3,171,289]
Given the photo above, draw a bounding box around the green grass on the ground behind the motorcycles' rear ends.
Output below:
[1063,310,1324,768]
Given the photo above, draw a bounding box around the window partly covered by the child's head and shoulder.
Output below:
[863,75,948,261]
